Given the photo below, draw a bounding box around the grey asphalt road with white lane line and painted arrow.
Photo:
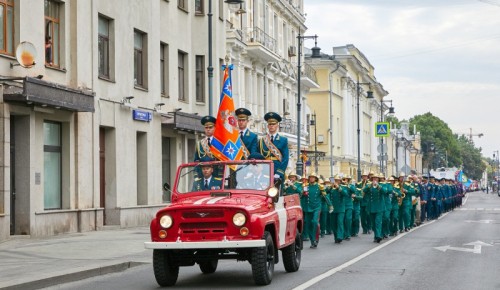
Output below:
[42,192,500,290]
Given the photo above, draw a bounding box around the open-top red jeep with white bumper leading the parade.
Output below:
[145,160,303,286]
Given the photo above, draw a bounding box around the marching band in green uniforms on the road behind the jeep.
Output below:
[285,172,465,248]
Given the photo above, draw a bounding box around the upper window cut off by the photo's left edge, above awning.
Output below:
[0,0,14,55]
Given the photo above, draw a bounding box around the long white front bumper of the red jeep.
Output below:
[144,240,266,250]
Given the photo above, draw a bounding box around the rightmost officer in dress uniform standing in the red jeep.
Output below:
[258,112,288,180]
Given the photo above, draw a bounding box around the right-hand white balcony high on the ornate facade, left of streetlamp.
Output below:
[244,27,280,63]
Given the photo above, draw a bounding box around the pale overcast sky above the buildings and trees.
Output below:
[304,0,500,158]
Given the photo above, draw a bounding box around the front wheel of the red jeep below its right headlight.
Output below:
[251,231,274,285]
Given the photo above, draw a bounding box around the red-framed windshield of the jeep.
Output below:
[177,161,271,194]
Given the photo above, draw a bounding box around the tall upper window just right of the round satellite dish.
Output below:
[45,0,62,67]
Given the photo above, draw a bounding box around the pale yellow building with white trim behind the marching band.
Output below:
[306,45,388,178]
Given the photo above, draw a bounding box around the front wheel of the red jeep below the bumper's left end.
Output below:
[153,250,179,287]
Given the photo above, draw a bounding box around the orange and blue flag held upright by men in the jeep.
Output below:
[211,65,243,161]
